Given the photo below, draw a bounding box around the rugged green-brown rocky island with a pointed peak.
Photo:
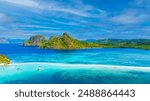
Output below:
[23,32,100,49]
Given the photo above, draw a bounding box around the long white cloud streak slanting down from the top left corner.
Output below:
[0,0,105,17]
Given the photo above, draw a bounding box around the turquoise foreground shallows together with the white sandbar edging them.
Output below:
[0,63,150,84]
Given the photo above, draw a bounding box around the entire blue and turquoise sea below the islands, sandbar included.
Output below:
[0,44,150,84]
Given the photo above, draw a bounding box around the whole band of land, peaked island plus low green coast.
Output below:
[23,32,150,50]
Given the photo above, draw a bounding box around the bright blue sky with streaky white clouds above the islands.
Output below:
[0,0,150,40]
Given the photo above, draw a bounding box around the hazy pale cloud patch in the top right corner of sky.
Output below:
[111,0,150,24]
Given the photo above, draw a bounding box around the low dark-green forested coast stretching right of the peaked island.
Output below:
[94,39,150,50]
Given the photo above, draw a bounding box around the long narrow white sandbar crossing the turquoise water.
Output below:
[9,62,150,72]
